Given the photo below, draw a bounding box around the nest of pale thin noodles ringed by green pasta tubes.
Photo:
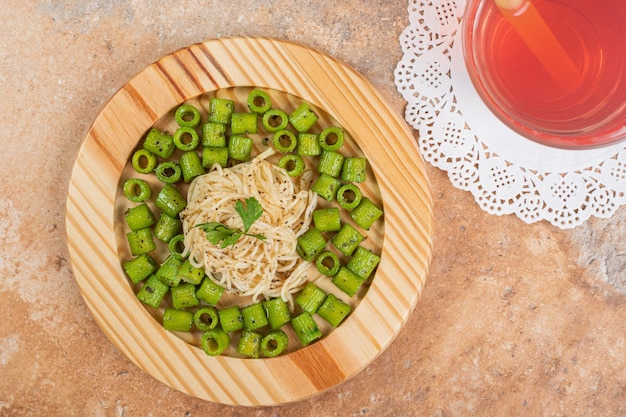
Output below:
[180,151,317,307]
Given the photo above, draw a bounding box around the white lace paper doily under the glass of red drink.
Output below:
[395,0,626,228]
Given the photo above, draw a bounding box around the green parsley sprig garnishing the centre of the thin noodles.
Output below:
[194,197,267,249]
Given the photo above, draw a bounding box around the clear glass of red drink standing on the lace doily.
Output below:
[461,0,626,149]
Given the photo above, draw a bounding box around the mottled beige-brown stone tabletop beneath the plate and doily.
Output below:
[0,0,626,417]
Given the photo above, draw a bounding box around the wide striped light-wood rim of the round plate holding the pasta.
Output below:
[66,37,433,406]
